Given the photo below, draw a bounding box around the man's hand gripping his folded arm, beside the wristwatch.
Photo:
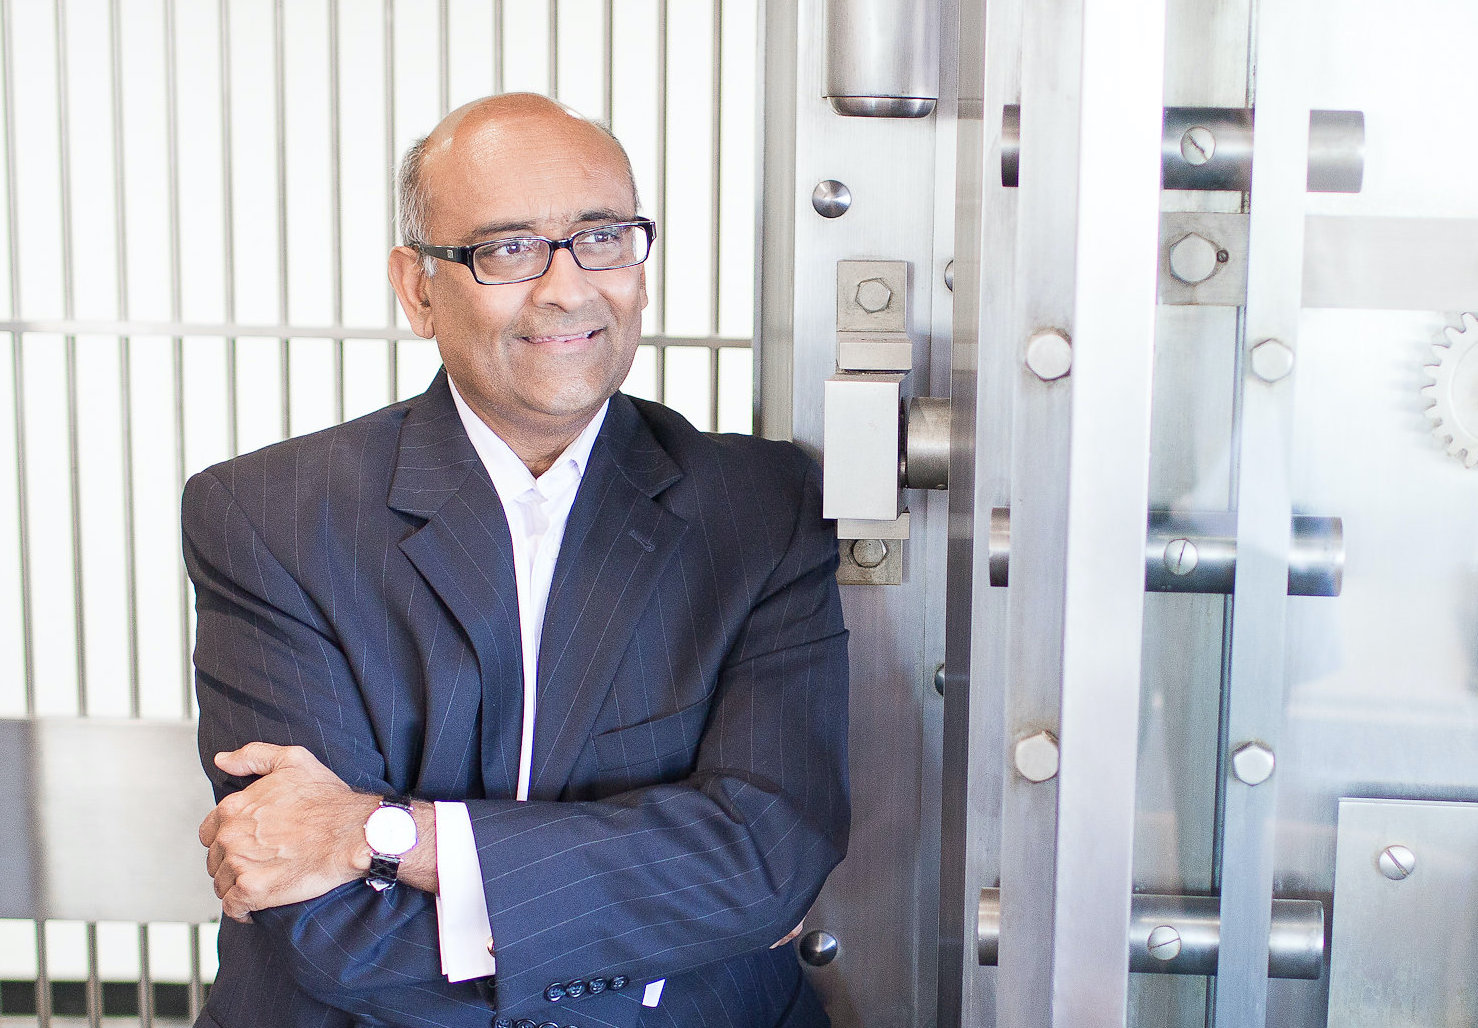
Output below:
[200,743,380,922]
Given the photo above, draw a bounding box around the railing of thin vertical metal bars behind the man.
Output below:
[0,0,757,1027]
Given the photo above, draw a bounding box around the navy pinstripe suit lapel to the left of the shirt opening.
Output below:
[387,371,523,796]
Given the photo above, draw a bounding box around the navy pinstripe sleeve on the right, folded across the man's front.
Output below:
[469,462,850,1015]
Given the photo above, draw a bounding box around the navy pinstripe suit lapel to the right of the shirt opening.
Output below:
[529,393,687,799]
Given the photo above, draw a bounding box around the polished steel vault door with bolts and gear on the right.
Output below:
[939,0,1478,1028]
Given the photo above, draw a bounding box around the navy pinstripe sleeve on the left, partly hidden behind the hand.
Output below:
[182,471,489,1028]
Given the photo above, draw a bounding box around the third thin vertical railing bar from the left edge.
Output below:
[108,0,142,718]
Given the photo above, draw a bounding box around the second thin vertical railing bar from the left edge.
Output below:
[52,0,87,716]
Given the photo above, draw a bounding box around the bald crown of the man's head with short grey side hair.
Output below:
[398,93,640,252]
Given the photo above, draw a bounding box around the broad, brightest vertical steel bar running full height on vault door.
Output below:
[1052,0,1165,1028]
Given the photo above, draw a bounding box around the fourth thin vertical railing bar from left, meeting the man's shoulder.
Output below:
[164,0,187,718]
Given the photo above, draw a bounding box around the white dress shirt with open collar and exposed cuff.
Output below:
[436,378,609,982]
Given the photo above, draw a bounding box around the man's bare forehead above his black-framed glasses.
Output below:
[423,115,636,242]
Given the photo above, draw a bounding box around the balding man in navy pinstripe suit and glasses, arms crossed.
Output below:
[183,95,848,1028]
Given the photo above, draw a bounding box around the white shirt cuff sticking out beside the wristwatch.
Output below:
[436,803,497,982]
